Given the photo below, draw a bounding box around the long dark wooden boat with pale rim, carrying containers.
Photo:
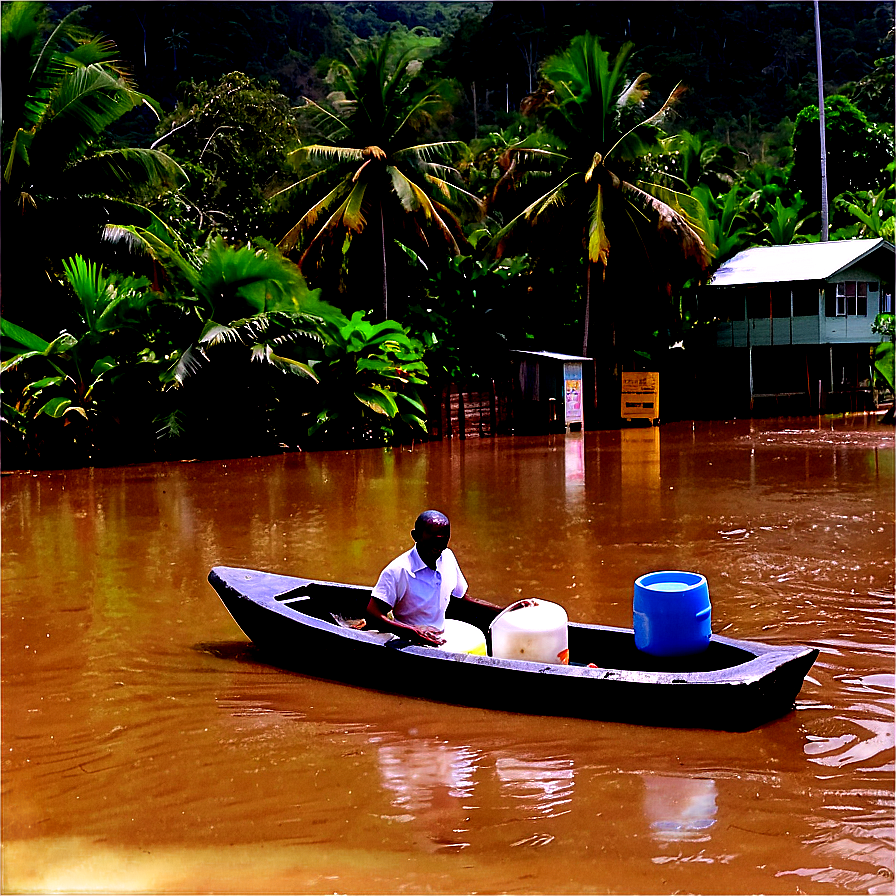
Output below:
[208,566,818,731]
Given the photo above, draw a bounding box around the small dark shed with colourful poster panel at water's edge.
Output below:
[511,351,594,433]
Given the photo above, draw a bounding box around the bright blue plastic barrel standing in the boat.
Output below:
[632,571,712,656]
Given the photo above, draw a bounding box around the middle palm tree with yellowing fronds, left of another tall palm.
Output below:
[278,36,479,318]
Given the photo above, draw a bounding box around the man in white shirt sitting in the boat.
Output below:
[367,510,496,646]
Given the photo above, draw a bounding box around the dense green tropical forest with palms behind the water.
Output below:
[0,0,896,468]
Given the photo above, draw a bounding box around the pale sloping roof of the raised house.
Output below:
[710,238,894,286]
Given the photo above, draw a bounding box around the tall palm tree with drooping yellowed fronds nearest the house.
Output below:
[495,34,709,355]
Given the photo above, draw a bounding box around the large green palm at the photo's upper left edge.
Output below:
[2,2,184,336]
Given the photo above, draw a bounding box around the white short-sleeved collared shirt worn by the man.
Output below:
[373,545,467,629]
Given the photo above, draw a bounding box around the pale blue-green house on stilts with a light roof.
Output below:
[701,238,894,409]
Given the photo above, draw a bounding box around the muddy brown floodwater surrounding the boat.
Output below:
[2,416,894,894]
